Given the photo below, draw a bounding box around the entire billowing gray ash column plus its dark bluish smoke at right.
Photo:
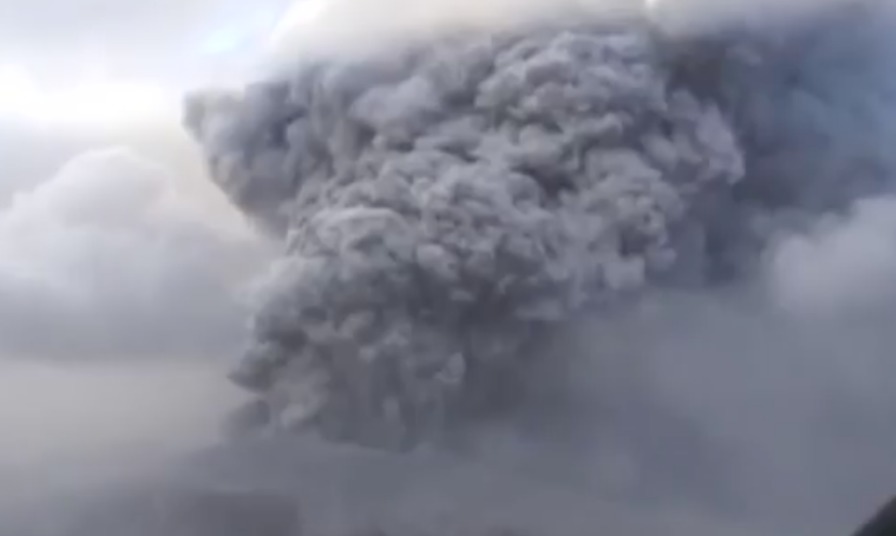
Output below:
[187,2,896,447]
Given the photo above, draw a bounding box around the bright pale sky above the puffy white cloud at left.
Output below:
[0,0,298,199]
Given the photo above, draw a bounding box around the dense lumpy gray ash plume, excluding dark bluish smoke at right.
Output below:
[190,16,743,448]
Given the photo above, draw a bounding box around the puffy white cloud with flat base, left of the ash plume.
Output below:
[0,149,268,357]
